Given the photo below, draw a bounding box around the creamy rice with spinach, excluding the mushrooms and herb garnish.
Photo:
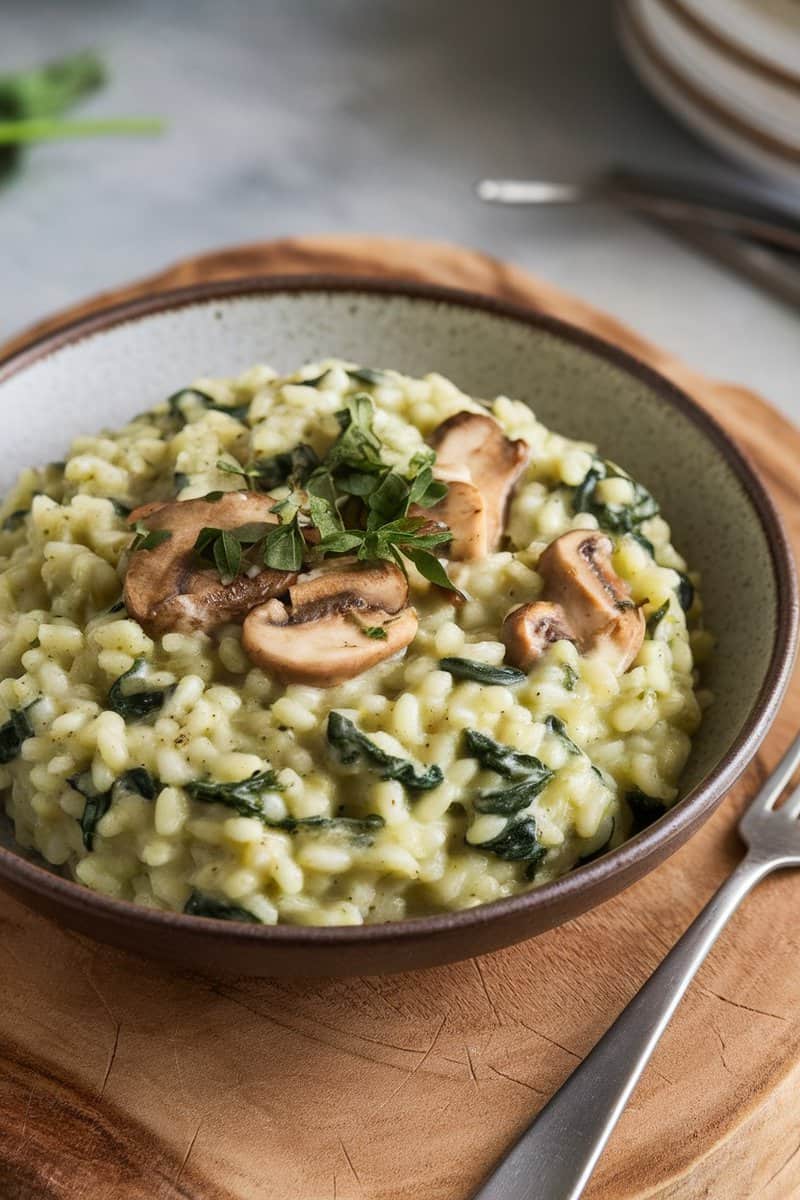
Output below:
[0,360,710,925]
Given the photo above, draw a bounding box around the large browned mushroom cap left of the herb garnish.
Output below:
[124,492,297,637]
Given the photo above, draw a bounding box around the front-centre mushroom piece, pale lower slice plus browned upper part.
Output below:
[242,563,417,688]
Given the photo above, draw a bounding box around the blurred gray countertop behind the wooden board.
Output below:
[0,0,800,420]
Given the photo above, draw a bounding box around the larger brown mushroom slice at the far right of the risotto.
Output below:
[536,529,645,674]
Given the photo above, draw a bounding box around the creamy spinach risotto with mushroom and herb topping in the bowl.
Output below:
[0,360,710,925]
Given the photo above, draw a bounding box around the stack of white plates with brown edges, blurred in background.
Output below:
[618,0,800,190]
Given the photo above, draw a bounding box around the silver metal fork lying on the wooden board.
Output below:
[473,736,800,1200]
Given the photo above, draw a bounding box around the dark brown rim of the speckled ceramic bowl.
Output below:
[0,274,798,953]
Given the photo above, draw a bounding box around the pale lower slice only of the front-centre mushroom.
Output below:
[242,593,417,688]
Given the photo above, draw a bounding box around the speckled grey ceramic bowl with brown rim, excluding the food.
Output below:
[0,277,798,976]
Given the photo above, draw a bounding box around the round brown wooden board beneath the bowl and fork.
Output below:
[0,238,800,1200]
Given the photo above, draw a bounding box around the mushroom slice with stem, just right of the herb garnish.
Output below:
[429,412,530,552]
